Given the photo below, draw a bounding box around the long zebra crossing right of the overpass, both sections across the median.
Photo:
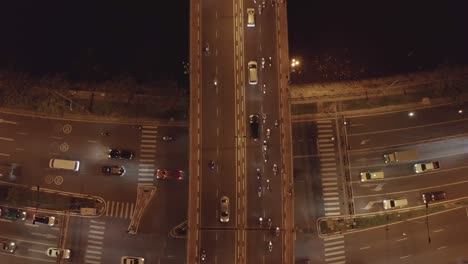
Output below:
[317,120,346,264]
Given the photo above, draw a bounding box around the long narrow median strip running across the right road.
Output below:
[317,199,468,237]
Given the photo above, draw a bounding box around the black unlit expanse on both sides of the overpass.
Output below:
[0,0,468,82]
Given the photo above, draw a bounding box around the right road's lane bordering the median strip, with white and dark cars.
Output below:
[353,179,468,213]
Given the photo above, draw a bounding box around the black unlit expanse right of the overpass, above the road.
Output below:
[288,0,468,83]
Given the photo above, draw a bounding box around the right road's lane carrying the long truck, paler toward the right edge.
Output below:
[348,136,468,167]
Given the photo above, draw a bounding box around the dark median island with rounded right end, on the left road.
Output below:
[0,184,105,217]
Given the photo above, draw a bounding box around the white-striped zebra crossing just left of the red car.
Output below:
[138,125,158,185]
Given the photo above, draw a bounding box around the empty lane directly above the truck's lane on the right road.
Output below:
[347,120,468,150]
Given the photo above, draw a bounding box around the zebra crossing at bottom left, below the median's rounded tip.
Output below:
[85,220,106,264]
